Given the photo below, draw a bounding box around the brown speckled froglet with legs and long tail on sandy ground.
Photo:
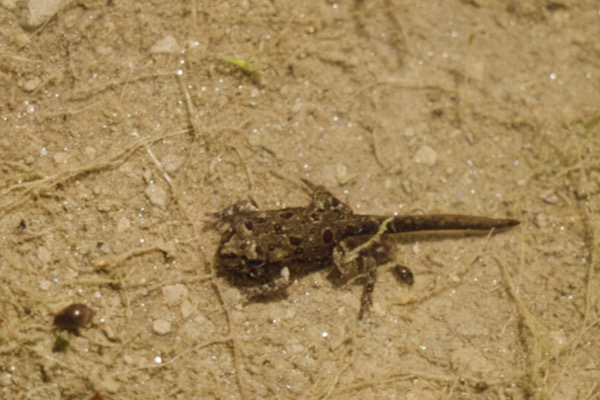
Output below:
[217,181,518,316]
